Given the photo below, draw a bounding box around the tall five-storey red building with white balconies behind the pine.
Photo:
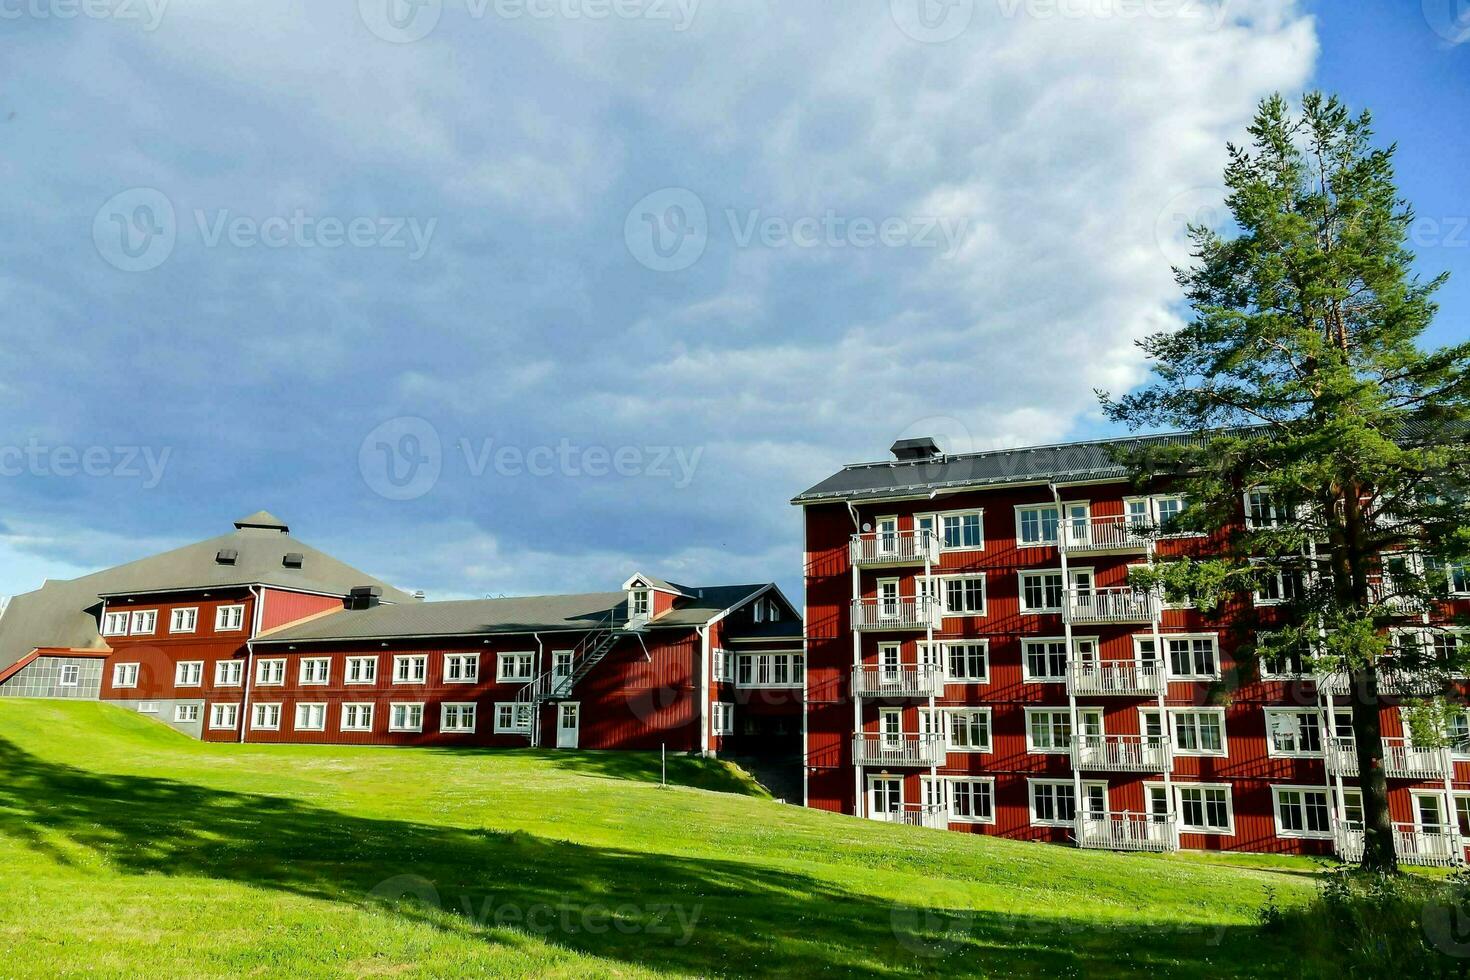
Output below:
[792,435,1470,864]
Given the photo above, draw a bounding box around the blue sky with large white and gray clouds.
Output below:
[0,0,1470,598]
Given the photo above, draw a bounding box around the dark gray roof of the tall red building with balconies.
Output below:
[791,432,1201,504]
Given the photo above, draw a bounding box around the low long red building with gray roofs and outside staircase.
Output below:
[0,511,804,758]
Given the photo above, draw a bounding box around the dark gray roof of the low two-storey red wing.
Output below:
[256,585,766,644]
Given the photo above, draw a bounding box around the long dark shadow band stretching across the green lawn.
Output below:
[0,739,1288,976]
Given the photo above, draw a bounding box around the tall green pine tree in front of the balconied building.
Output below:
[1100,94,1470,871]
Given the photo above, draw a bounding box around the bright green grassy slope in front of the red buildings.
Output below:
[0,699,1311,976]
